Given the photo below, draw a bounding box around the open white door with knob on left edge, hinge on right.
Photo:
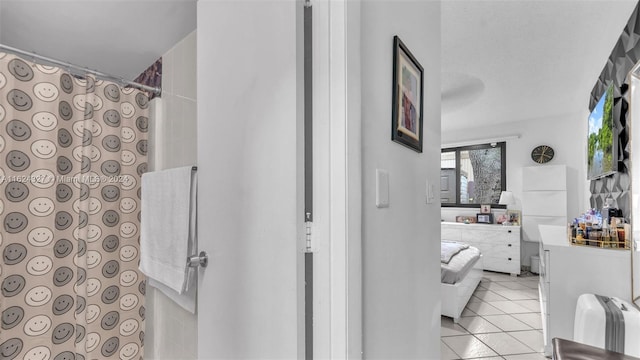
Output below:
[197,0,303,359]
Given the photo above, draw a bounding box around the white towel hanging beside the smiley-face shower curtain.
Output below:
[140,166,197,296]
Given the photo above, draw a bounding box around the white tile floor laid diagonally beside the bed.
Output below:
[440,271,546,360]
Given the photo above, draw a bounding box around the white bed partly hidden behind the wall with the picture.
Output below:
[440,241,483,323]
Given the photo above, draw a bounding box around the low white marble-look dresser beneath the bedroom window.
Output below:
[441,222,520,275]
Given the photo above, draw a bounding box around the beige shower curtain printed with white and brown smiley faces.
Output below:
[0,52,148,360]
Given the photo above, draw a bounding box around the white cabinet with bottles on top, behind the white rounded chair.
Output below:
[538,225,631,355]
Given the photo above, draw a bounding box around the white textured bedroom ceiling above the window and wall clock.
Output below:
[441,0,637,132]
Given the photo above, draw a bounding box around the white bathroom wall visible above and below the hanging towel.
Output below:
[145,31,197,359]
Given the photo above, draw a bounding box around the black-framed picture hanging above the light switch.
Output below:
[391,36,424,153]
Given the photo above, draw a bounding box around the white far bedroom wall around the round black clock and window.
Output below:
[441,108,589,266]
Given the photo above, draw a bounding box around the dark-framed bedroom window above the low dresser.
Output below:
[440,142,507,208]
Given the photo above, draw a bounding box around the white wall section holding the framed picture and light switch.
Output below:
[361,1,440,359]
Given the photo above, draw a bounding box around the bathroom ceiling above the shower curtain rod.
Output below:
[0,0,196,80]
